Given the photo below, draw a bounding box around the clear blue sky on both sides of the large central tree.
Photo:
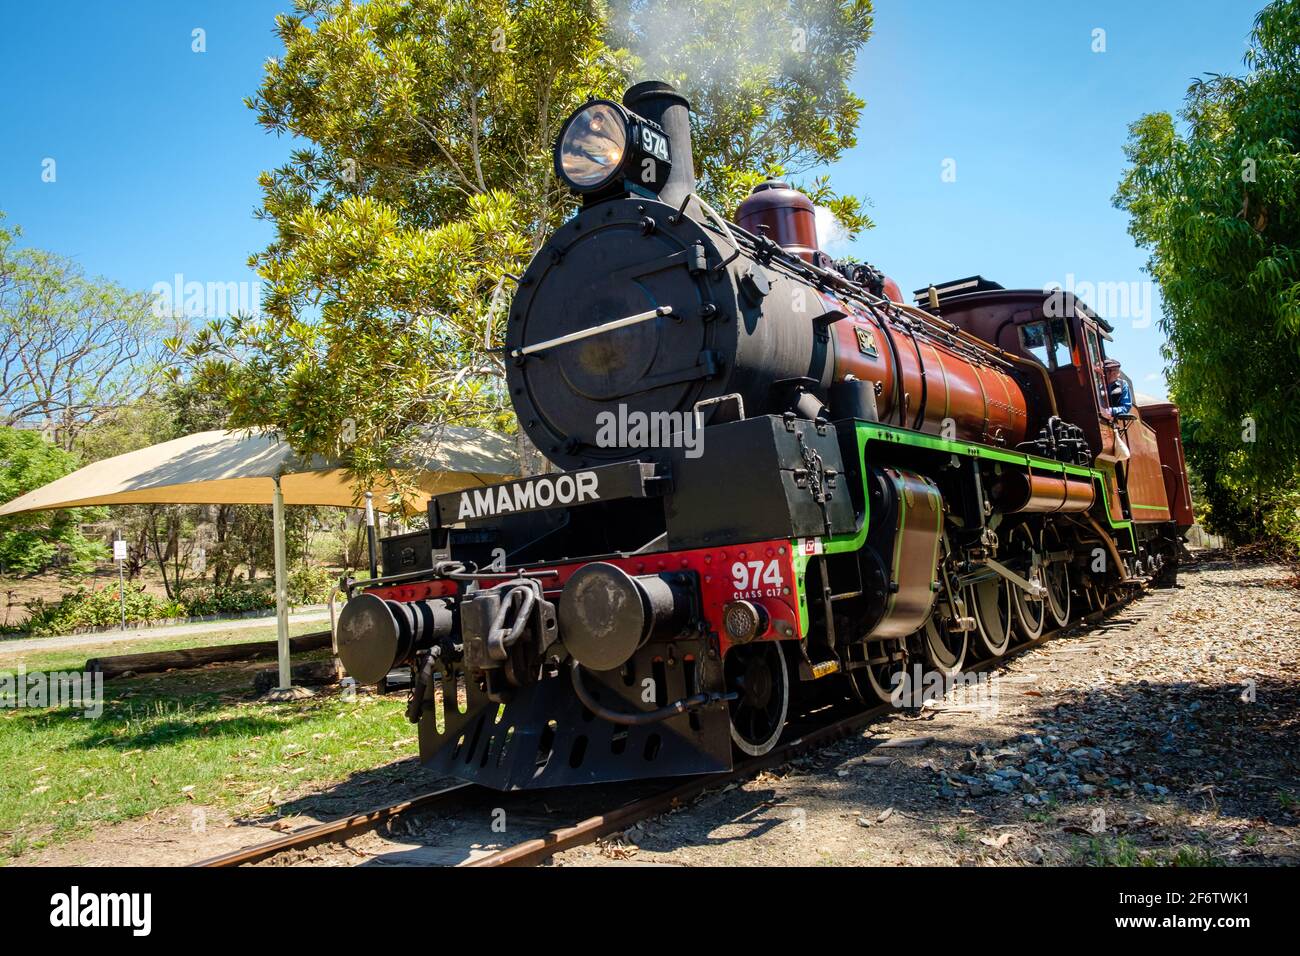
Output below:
[0,0,1264,394]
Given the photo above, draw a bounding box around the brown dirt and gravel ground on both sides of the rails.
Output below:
[12,548,1300,866]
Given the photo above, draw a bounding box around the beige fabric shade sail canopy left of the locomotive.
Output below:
[0,425,519,515]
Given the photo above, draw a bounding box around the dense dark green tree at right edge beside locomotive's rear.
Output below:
[1115,0,1300,533]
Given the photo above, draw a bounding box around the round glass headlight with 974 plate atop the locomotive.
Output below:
[555,100,672,195]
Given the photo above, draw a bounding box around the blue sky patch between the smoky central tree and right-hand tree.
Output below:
[832,0,1264,395]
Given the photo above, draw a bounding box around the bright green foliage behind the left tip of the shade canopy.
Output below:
[0,428,108,575]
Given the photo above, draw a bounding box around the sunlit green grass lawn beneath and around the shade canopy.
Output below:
[0,623,416,862]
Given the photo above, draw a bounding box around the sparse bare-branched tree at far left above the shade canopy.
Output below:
[0,213,178,450]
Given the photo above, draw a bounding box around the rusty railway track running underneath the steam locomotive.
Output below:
[195,592,1164,868]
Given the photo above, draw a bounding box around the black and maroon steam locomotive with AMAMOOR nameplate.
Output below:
[337,82,1193,790]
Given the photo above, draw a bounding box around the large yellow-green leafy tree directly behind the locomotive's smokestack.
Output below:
[185,0,871,489]
